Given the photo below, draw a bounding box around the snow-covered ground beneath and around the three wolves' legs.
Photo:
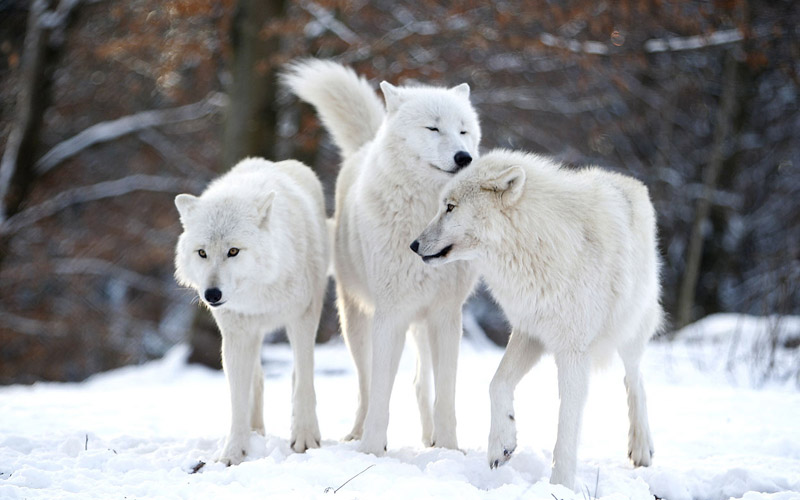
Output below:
[0,315,800,500]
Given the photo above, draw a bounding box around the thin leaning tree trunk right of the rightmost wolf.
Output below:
[675,53,738,328]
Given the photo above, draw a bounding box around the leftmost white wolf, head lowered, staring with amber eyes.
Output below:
[175,158,329,465]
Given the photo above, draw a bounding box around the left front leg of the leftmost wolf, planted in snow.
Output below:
[219,329,262,465]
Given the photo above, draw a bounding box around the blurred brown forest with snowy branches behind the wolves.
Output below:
[0,0,800,383]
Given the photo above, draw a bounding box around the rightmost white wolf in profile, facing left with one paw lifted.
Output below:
[412,150,662,487]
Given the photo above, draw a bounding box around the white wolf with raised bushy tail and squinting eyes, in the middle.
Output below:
[284,60,480,455]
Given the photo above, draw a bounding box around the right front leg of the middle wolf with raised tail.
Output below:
[428,303,461,449]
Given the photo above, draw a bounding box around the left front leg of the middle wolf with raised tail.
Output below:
[358,307,410,456]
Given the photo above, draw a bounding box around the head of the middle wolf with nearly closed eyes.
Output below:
[381,82,481,174]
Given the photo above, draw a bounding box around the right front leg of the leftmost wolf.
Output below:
[286,306,321,453]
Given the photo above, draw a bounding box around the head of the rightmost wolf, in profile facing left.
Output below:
[411,151,526,265]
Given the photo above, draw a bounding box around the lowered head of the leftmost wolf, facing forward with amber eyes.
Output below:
[175,192,278,313]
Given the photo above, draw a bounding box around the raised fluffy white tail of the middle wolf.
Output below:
[281,59,385,157]
